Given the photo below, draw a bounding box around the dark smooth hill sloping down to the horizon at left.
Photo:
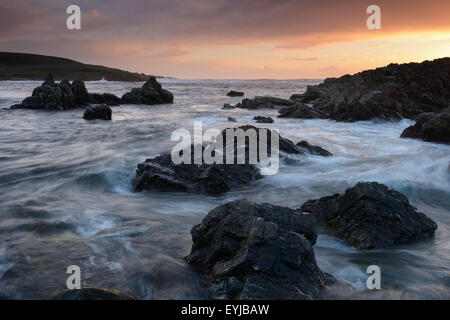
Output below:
[0,52,164,82]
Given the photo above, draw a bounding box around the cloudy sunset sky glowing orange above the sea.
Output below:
[0,0,450,79]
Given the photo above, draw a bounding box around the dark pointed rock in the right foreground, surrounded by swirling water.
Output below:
[301,182,437,249]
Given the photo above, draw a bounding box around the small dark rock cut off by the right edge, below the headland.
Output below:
[401,107,450,143]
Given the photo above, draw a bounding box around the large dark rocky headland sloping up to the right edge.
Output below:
[286,58,450,122]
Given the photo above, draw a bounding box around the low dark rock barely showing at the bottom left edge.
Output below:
[50,288,136,300]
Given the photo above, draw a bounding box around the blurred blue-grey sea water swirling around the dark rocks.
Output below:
[0,79,450,299]
